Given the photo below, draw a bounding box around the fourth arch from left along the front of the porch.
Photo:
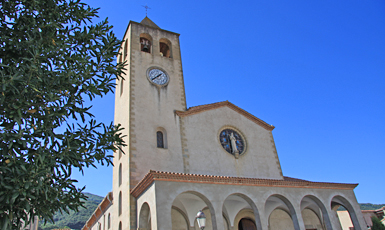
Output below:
[300,195,333,230]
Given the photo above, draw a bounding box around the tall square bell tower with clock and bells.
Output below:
[112,16,186,230]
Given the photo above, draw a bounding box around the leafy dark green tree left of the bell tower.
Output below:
[0,0,125,229]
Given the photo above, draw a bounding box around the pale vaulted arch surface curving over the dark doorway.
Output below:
[222,193,262,230]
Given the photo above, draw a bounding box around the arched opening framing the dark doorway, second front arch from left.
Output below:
[222,194,262,230]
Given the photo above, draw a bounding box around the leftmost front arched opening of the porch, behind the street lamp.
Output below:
[171,191,216,230]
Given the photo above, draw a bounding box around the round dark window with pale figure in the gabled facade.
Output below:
[219,129,245,155]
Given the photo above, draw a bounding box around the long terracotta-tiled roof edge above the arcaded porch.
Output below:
[131,170,358,198]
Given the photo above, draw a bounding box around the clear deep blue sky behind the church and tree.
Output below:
[74,0,385,203]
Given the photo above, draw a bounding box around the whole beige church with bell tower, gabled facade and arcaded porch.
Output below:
[83,16,366,230]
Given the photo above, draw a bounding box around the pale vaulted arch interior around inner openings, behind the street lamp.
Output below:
[171,191,219,230]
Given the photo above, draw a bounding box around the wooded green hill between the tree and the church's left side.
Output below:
[39,193,104,230]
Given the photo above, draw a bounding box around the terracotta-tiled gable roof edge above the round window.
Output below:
[175,101,275,131]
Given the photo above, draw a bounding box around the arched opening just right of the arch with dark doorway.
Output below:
[265,194,300,230]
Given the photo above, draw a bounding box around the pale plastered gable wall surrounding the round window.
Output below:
[183,107,283,179]
